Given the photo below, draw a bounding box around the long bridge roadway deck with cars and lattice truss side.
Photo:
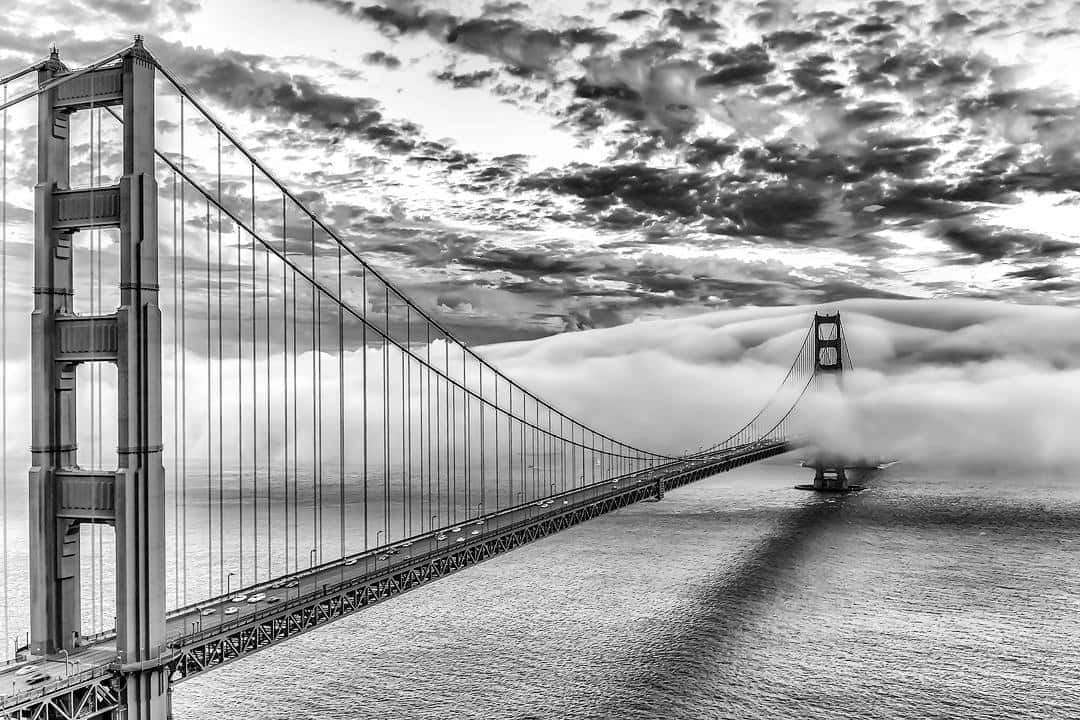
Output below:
[0,441,796,717]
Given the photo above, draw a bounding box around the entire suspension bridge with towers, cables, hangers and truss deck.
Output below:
[0,38,851,720]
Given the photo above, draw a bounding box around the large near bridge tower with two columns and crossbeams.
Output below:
[29,38,168,720]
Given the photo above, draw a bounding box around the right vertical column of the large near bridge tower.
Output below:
[116,39,168,720]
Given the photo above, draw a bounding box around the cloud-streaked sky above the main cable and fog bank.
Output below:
[6,0,1080,342]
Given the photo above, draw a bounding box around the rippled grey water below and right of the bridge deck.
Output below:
[174,460,1080,720]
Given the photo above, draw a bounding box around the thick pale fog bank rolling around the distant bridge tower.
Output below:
[487,300,1080,467]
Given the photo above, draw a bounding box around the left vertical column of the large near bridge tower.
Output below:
[28,51,80,655]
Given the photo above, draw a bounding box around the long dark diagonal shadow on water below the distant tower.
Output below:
[588,494,859,718]
